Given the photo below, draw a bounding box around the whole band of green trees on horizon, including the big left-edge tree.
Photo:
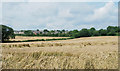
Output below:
[0,25,120,41]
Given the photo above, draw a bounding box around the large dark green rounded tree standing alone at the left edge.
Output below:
[0,25,15,42]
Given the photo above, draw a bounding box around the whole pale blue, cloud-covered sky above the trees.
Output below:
[2,2,118,30]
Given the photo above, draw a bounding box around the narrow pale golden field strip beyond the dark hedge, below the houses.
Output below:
[10,36,68,41]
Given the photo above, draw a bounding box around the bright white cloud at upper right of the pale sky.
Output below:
[86,2,117,22]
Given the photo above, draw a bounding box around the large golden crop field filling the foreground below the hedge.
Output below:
[2,36,118,69]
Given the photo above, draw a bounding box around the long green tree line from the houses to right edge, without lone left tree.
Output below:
[19,26,120,38]
